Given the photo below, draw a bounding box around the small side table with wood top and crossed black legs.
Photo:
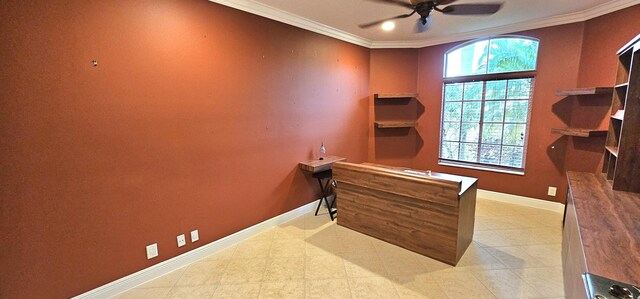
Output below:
[299,156,347,221]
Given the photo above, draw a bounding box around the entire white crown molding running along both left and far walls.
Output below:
[209,0,640,49]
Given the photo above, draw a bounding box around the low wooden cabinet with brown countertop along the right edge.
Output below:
[563,171,640,298]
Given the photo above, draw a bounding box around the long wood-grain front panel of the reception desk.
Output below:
[337,182,458,265]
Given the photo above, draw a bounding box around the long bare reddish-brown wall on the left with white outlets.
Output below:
[0,0,369,298]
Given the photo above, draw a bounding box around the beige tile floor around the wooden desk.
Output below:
[116,199,564,299]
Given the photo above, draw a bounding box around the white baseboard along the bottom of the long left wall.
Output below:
[73,201,317,299]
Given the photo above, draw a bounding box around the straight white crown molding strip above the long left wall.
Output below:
[209,0,372,48]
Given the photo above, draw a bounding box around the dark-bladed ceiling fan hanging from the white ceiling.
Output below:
[358,0,502,32]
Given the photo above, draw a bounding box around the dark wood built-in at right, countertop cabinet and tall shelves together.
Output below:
[562,35,640,299]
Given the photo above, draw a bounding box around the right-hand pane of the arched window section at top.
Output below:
[488,37,538,74]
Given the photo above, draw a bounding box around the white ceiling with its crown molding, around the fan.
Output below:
[210,0,640,48]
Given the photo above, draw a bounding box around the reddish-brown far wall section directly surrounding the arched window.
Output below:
[412,24,583,200]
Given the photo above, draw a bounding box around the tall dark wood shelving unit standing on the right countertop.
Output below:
[603,35,640,192]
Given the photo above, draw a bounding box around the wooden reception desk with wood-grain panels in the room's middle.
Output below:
[333,162,477,265]
